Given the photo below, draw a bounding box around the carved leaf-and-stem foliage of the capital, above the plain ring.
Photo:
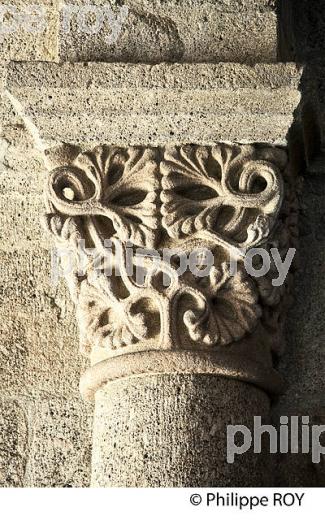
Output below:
[45,144,290,374]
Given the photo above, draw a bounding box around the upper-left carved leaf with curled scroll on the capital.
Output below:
[46,146,159,251]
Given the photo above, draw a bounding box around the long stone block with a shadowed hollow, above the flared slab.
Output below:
[59,0,277,63]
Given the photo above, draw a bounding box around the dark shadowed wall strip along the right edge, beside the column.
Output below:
[273,0,325,486]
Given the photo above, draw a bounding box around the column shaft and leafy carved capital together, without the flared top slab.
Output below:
[46,140,292,486]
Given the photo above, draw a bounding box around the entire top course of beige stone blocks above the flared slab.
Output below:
[0,0,277,63]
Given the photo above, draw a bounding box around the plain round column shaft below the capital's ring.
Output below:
[92,375,272,487]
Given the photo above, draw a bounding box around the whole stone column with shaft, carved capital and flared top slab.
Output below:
[6,64,300,486]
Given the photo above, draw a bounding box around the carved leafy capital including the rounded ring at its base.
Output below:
[41,144,297,396]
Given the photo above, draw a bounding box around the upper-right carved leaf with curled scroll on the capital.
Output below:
[161,145,283,254]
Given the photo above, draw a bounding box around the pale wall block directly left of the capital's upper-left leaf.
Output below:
[0,124,53,250]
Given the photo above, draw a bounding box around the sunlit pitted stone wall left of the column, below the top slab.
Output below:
[0,118,92,487]
